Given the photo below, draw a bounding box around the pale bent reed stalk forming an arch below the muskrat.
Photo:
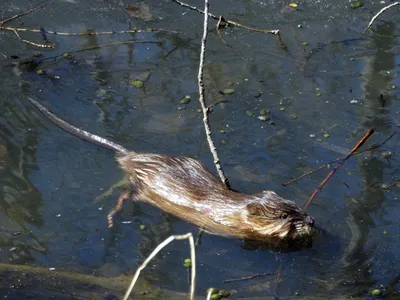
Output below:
[123,232,196,300]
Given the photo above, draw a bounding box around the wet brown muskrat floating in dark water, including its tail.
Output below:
[28,97,314,242]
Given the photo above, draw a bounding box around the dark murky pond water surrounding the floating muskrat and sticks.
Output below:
[0,1,400,299]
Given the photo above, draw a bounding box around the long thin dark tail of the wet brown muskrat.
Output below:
[27,97,129,154]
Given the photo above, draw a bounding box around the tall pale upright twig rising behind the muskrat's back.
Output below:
[197,0,230,189]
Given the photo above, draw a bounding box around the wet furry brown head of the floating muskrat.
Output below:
[245,191,314,239]
